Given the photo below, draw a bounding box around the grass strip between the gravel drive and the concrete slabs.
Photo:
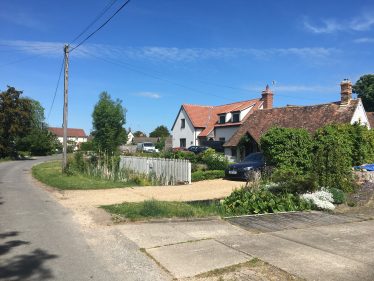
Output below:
[101,200,224,221]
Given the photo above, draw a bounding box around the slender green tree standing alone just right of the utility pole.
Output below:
[92,92,126,153]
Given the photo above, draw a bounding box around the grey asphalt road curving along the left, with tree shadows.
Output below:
[0,158,126,281]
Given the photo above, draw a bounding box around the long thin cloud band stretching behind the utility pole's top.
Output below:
[0,40,339,62]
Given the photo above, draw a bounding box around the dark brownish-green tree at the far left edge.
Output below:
[0,86,33,157]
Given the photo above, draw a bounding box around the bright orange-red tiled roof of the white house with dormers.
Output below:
[182,99,261,137]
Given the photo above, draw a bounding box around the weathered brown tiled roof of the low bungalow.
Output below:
[224,100,358,147]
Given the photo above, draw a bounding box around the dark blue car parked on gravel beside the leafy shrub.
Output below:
[225,152,265,180]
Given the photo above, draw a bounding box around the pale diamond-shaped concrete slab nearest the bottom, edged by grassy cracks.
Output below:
[147,237,251,278]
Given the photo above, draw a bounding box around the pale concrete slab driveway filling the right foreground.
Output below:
[116,212,374,281]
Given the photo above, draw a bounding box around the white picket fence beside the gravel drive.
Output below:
[120,156,191,185]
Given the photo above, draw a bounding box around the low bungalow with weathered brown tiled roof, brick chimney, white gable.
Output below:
[224,80,371,161]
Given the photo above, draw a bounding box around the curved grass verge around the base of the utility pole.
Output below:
[32,161,137,189]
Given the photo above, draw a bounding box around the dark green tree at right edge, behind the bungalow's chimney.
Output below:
[353,74,374,112]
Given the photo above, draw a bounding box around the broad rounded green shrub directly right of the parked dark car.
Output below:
[260,127,313,174]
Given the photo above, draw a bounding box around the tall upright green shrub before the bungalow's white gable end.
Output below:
[313,125,354,192]
